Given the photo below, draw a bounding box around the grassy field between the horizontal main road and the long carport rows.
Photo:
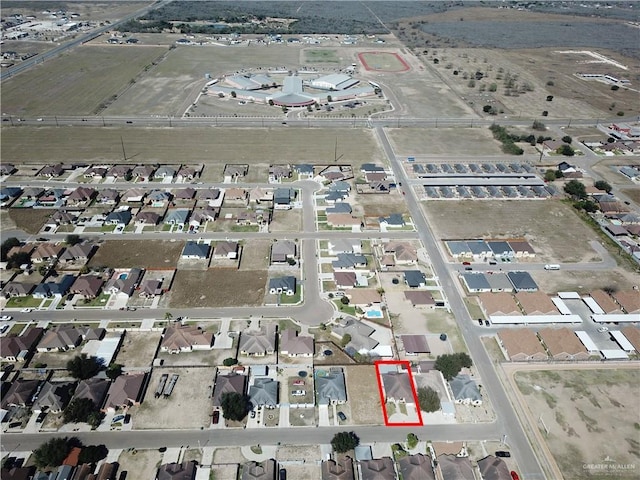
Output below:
[387,128,502,158]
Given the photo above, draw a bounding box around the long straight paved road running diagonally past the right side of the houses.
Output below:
[375,128,545,480]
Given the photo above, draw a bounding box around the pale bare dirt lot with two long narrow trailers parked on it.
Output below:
[131,368,215,430]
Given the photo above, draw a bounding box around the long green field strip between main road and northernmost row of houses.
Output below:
[2,127,383,164]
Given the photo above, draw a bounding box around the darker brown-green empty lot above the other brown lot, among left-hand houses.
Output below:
[89,240,184,269]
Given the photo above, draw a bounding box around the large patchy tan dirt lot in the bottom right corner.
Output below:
[514,366,640,479]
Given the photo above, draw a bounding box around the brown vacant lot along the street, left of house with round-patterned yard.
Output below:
[170,270,267,308]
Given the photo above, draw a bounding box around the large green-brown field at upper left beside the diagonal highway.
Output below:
[0,46,166,115]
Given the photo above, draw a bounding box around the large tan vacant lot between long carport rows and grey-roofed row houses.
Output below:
[423,200,599,262]
